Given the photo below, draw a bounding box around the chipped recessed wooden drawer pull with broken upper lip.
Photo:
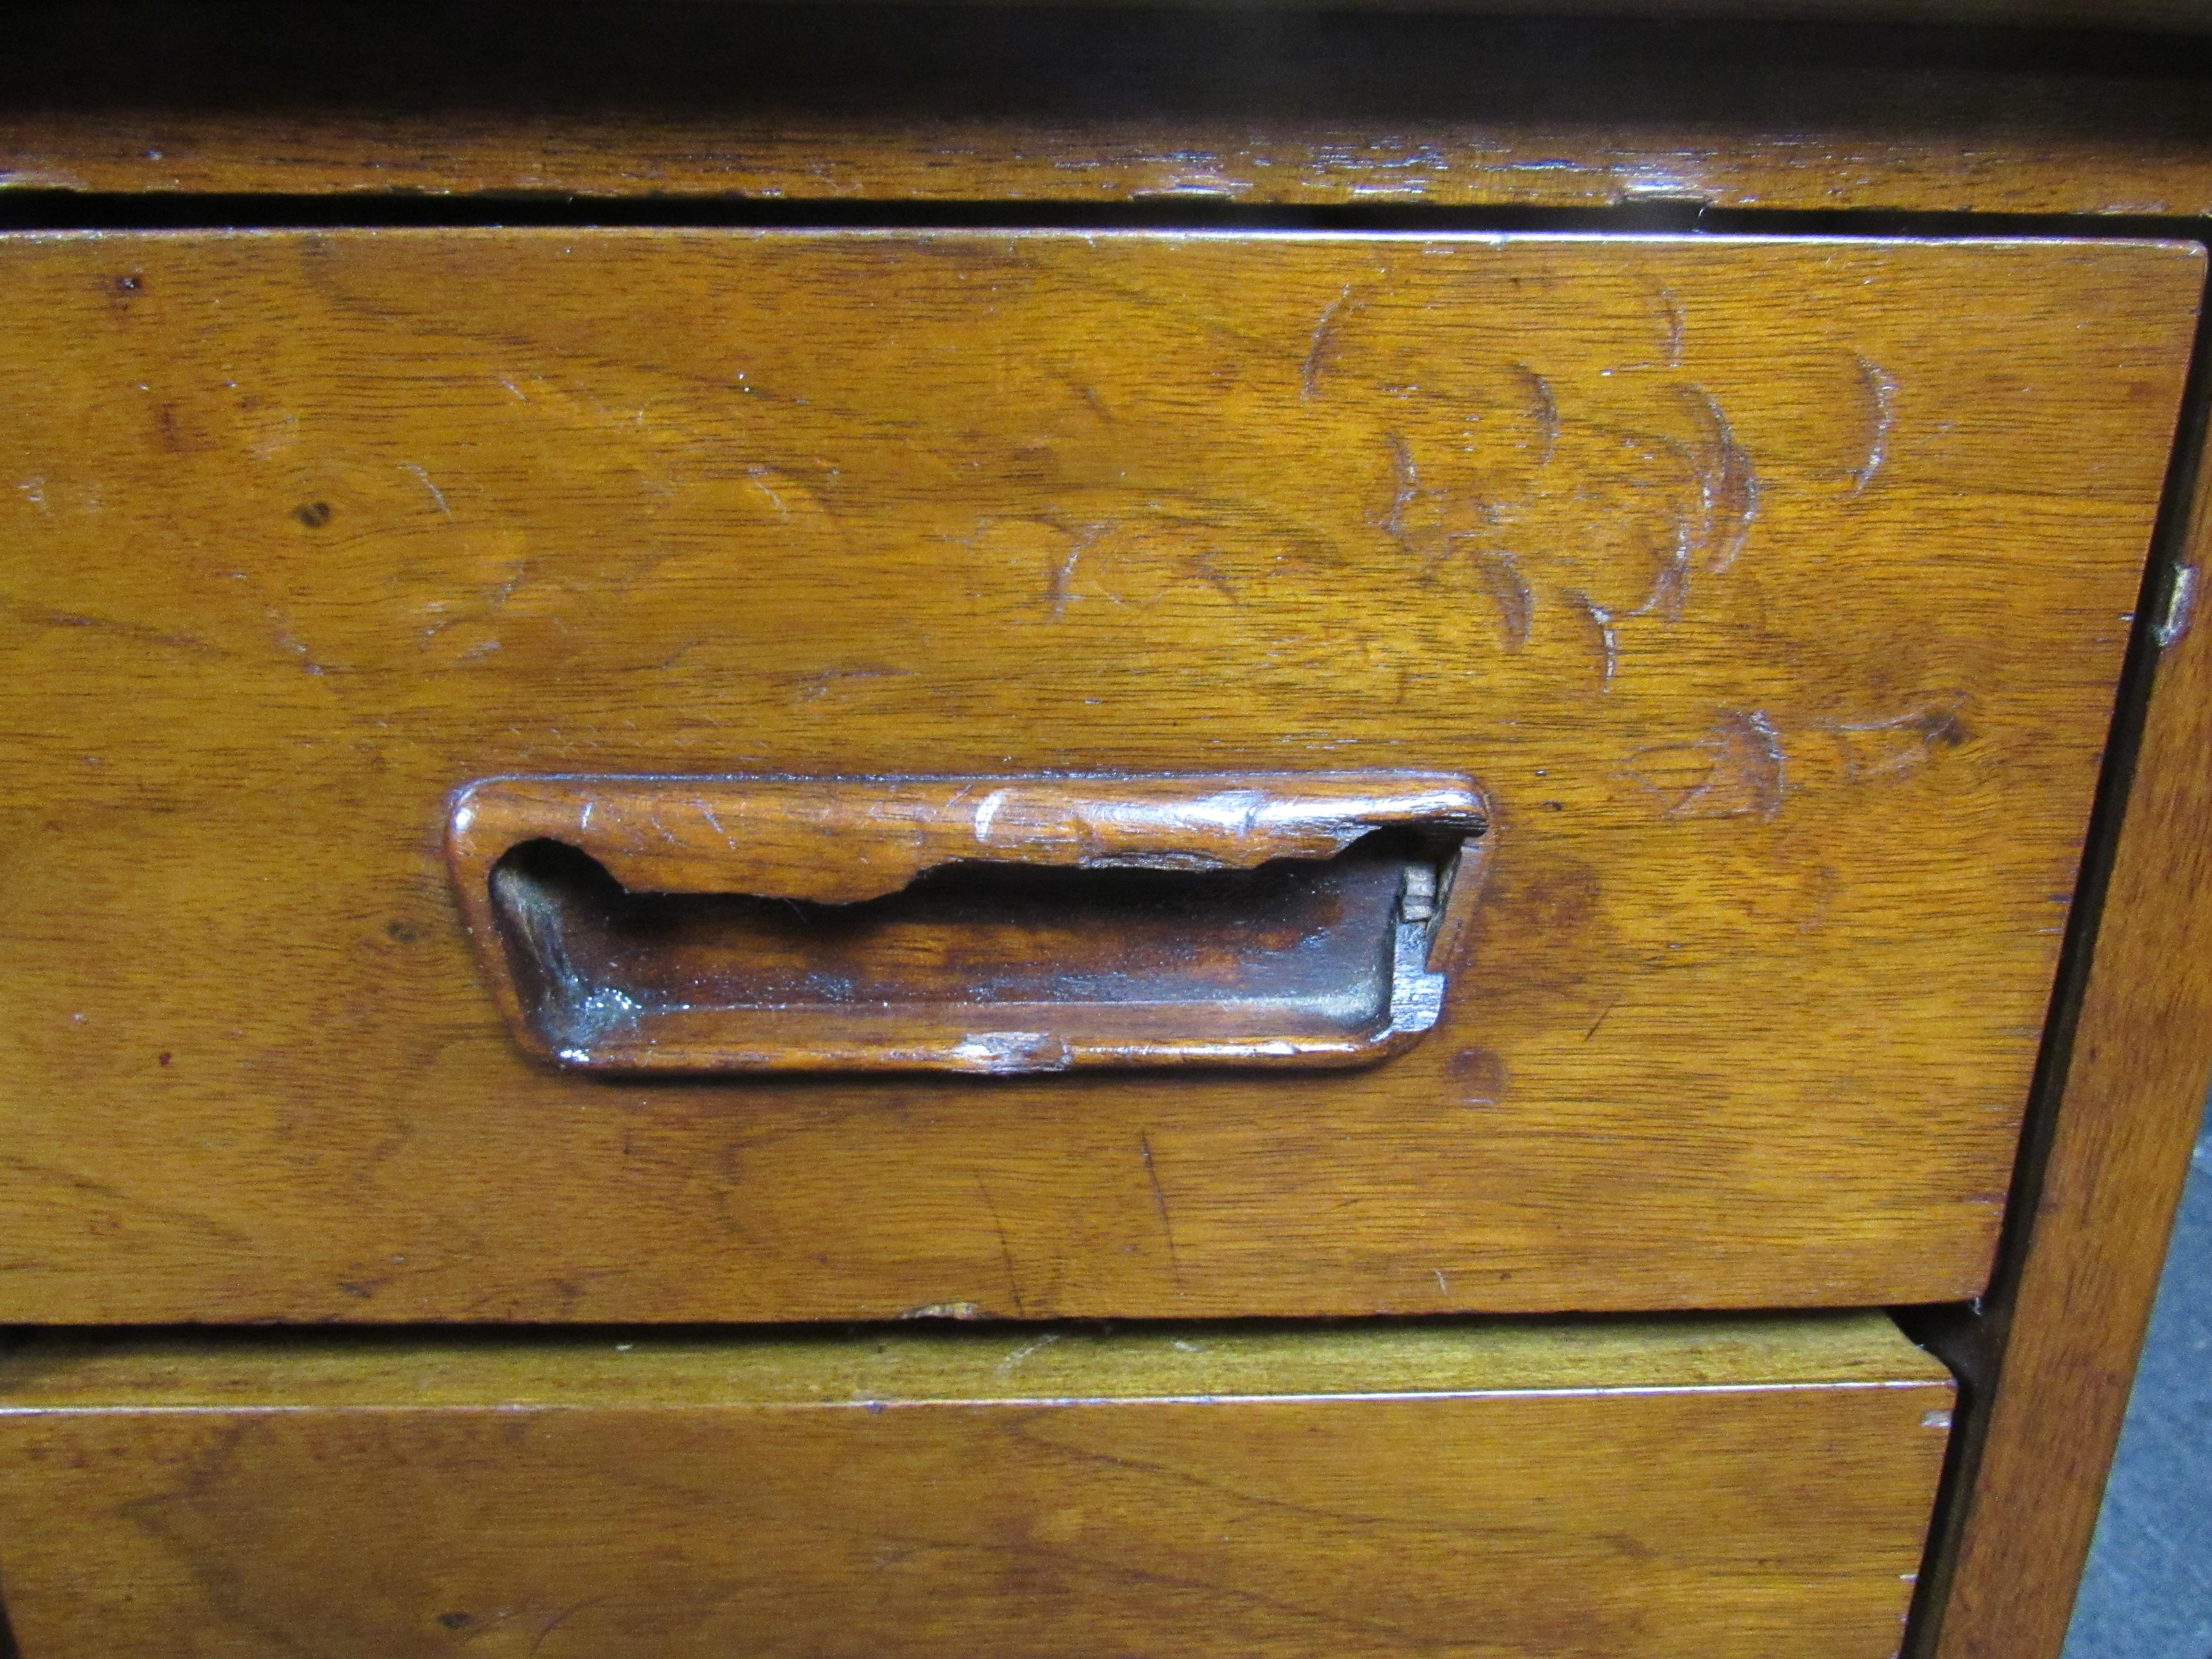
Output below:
[447,772,1489,1073]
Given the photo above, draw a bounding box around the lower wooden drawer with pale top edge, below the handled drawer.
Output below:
[0,1314,1951,1659]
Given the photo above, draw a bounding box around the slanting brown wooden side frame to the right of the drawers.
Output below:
[1907,256,2212,1659]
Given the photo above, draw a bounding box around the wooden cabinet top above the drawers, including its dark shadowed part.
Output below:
[13,0,2212,223]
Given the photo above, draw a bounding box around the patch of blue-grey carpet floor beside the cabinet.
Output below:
[2066,1106,2212,1659]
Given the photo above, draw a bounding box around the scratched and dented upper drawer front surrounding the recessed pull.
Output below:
[0,232,2201,1321]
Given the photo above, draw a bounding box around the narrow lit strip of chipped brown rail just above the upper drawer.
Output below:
[21,110,2212,223]
